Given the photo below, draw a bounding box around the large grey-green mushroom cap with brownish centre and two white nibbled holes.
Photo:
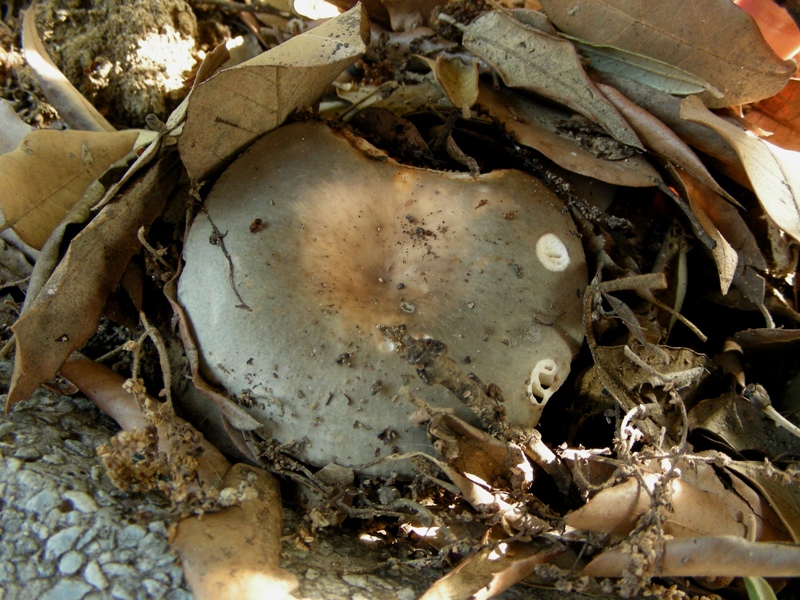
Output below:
[178,123,587,474]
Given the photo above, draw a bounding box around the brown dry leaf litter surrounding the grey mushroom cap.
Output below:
[0,0,800,598]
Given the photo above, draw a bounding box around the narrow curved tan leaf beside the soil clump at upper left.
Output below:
[22,5,115,131]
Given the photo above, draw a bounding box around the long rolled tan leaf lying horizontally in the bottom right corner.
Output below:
[583,536,800,577]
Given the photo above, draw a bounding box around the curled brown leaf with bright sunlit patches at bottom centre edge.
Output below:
[420,540,563,600]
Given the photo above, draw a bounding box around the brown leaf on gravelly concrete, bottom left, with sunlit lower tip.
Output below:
[172,463,298,600]
